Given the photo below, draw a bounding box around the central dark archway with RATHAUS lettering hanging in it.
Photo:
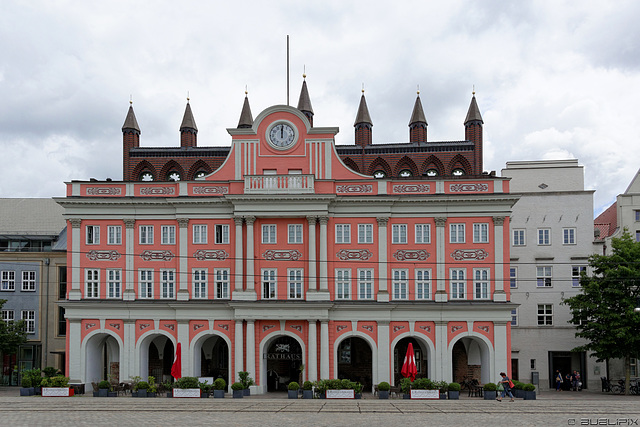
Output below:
[260,335,304,391]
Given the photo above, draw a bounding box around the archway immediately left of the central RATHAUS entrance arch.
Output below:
[192,334,233,385]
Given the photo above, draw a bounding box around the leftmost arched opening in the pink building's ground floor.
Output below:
[84,333,120,383]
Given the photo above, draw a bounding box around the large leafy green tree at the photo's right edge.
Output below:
[563,230,640,394]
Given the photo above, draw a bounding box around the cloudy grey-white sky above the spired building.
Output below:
[0,0,640,214]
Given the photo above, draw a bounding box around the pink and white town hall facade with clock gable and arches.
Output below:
[57,106,517,393]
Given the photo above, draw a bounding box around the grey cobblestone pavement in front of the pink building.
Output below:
[0,387,640,426]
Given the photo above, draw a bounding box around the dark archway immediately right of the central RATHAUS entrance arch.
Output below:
[336,336,373,390]
